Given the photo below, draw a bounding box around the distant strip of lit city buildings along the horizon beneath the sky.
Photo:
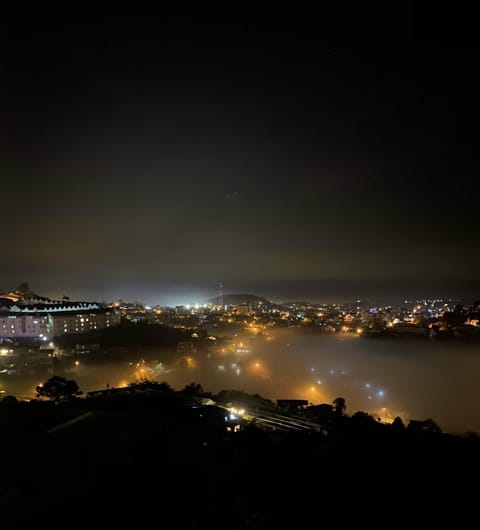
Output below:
[0,284,480,374]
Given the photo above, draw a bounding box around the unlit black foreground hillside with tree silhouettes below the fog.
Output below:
[0,386,480,529]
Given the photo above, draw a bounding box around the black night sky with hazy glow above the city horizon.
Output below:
[0,10,480,303]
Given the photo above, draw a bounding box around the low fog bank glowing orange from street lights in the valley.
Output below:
[2,330,480,433]
